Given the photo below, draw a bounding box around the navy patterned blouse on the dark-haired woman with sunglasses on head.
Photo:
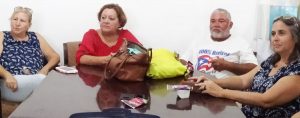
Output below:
[241,55,300,118]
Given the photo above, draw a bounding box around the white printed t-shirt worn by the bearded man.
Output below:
[182,35,257,78]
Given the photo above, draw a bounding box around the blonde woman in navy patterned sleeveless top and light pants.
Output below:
[0,7,59,101]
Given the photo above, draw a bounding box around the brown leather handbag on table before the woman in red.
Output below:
[104,39,152,81]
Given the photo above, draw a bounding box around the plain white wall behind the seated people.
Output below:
[0,0,259,64]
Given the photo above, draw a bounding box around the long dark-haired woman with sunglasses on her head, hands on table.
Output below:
[192,16,300,118]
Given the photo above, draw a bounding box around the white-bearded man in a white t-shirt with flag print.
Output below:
[183,8,257,78]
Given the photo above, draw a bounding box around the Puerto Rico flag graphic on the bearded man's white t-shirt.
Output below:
[196,55,214,71]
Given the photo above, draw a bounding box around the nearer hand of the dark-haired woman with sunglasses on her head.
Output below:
[195,80,224,97]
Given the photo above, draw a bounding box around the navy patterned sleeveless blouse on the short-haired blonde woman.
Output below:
[0,31,45,75]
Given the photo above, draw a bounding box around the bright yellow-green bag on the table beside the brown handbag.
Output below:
[147,48,187,79]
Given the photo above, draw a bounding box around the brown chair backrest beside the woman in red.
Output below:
[63,41,81,66]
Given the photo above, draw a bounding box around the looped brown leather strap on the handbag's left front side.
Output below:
[104,51,130,79]
